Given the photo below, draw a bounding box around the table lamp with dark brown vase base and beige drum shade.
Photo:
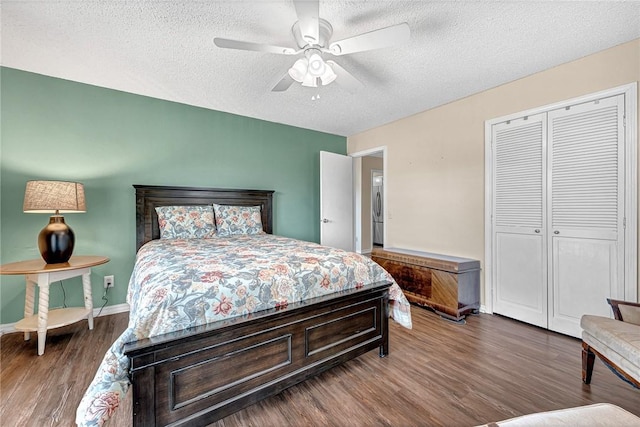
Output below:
[23,181,87,264]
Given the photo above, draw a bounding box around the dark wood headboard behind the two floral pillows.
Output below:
[134,185,273,252]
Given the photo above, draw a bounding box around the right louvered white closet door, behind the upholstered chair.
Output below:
[548,95,624,336]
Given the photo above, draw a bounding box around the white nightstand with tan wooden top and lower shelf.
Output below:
[0,256,109,356]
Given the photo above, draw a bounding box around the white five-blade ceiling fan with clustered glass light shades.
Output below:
[213,0,410,93]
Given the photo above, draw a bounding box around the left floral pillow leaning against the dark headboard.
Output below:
[156,205,216,239]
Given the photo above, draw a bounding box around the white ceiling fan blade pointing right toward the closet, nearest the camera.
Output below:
[329,22,411,55]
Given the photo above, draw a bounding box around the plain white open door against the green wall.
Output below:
[320,151,354,251]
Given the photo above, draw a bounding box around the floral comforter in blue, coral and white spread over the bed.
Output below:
[76,234,411,426]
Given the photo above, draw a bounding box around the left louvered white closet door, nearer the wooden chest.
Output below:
[491,114,547,327]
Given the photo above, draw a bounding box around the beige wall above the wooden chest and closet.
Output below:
[347,39,640,302]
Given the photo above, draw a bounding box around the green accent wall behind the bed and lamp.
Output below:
[0,67,346,324]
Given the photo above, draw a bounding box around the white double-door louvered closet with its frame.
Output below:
[486,86,637,337]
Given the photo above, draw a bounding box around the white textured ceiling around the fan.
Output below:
[0,0,640,136]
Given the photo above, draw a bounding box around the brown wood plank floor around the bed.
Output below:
[0,307,640,427]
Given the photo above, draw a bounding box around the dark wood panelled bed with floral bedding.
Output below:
[76,185,411,426]
